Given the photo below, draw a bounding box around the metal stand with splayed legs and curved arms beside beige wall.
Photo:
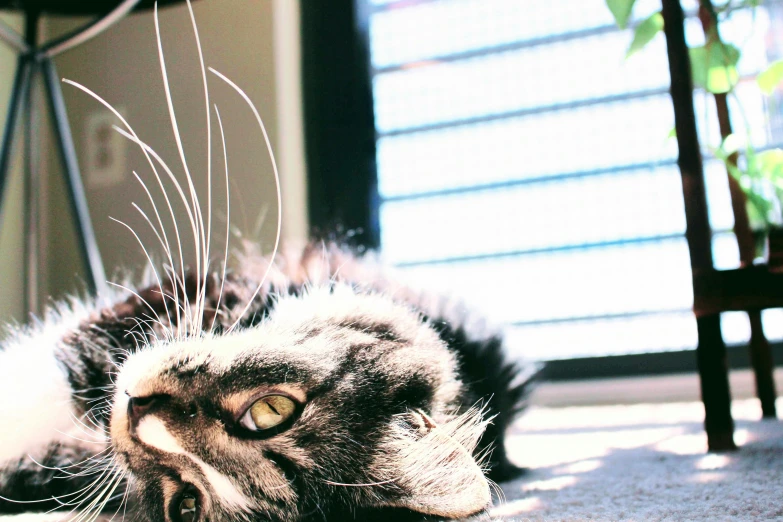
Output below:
[0,0,140,312]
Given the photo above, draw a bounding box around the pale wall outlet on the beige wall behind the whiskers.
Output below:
[82,108,129,188]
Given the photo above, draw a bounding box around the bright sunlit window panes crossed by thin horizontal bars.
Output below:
[304,0,783,366]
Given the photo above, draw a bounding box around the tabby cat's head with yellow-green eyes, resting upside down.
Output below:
[110,286,490,522]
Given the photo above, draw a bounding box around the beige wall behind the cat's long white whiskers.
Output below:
[10,0,307,308]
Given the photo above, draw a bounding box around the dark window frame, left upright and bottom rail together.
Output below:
[301,0,783,381]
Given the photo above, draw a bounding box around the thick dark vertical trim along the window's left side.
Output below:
[301,0,380,248]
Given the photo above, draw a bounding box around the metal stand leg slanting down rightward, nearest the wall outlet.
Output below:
[40,58,106,292]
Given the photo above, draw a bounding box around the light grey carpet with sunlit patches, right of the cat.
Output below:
[485,400,783,522]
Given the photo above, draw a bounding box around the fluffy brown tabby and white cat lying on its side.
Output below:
[0,3,533,522]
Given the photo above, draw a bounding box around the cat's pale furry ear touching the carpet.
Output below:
[374,410,491,518]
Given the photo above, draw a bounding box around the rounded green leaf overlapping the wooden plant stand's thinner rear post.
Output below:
[689,42,740,94]
